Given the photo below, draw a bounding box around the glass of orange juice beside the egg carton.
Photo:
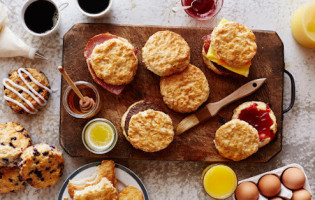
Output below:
[202,164,237,199]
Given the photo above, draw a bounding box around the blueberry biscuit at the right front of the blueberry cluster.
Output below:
[19,143,64,188]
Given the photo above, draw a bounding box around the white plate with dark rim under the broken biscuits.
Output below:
[58,162,149,200]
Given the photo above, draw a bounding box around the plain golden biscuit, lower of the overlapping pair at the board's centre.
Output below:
[160,65,210,113]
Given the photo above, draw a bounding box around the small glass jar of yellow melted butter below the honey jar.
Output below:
[82,118,118,154]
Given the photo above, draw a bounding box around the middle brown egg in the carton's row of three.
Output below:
[258,174,281,197]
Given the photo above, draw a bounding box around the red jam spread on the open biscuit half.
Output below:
[238,103,275,141]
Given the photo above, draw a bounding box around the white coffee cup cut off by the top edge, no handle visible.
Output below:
[76,0,113,18]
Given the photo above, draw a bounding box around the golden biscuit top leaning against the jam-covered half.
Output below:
[215,119,259,161]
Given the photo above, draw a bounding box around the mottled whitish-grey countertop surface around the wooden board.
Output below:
[0,0,315,200]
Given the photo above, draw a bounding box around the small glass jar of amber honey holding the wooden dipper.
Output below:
[62,81,101,119]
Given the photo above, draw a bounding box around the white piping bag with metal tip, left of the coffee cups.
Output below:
[0,2,37,59]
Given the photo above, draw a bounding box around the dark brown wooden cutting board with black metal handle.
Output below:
[60,24,284,162]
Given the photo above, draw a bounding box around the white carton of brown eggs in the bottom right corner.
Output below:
[233,164,312,200]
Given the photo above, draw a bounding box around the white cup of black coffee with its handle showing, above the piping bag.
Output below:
[21,0,69,36]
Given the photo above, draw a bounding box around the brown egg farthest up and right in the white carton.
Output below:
[282,167,305,190]
